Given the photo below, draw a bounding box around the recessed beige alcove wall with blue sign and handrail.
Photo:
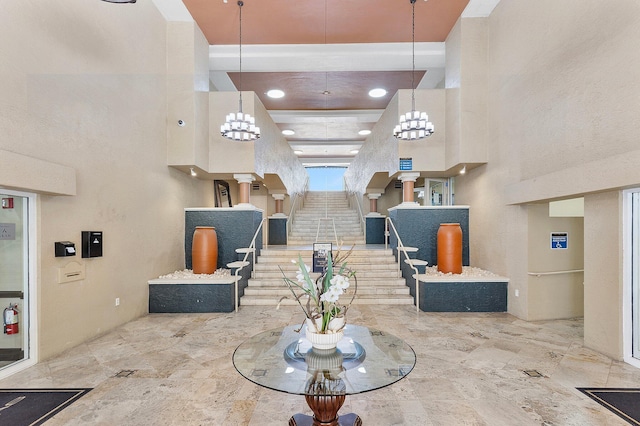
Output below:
[526,203,584,321]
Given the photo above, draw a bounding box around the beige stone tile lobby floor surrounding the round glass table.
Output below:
[0,305,640,426]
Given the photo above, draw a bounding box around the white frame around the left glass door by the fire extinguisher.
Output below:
[0,187,39,379]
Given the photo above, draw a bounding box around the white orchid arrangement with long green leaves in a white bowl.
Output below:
[278,248,358,334]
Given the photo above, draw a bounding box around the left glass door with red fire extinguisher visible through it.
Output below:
[0,189,30,370]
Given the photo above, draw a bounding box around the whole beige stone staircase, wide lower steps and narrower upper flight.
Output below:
[240,192,414,307]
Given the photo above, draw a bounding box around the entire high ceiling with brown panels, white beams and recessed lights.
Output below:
[183,0,499,165]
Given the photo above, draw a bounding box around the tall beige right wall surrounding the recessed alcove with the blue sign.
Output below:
[456,0,640,358]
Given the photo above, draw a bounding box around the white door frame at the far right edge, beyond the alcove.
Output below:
[622,188,640,368]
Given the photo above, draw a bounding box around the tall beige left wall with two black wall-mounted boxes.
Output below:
[0,0,212,359]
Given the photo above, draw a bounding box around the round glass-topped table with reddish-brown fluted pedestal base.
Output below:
[233,324,416,426]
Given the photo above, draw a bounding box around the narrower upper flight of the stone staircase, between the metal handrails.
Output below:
[288,191,364,247]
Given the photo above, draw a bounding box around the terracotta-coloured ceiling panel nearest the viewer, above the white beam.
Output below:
[183,0,469,44]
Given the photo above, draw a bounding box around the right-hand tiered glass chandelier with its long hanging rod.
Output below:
[393,0,434,141]
